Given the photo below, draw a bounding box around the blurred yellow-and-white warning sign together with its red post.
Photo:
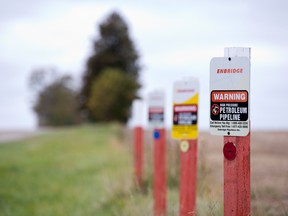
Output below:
[172,78,199,216]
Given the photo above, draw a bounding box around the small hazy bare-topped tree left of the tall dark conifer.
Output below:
[30,69,80,126]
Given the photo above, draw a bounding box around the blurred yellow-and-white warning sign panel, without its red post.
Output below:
[172,78,199,139]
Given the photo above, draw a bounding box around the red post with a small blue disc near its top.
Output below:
[154,128,166,216]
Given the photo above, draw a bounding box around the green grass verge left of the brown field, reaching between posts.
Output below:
[0,124,227,216]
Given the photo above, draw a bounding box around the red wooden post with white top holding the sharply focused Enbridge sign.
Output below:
[224,48,251,216]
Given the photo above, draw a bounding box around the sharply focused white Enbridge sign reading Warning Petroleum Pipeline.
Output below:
[210,57,250,136]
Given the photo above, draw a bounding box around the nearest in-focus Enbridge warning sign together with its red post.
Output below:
[210,47,250,216]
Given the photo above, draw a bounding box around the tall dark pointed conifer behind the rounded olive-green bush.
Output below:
[79,12,140,121]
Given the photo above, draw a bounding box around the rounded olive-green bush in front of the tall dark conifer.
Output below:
[87,69,138,122]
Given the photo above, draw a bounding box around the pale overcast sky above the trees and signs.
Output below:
[0,0,288,129]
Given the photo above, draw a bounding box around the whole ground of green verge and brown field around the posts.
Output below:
[0,125,288,216]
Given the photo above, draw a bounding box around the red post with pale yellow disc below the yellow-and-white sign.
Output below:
[179,139,197,216]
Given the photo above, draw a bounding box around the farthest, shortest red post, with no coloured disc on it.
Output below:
[134,126,143,189]
